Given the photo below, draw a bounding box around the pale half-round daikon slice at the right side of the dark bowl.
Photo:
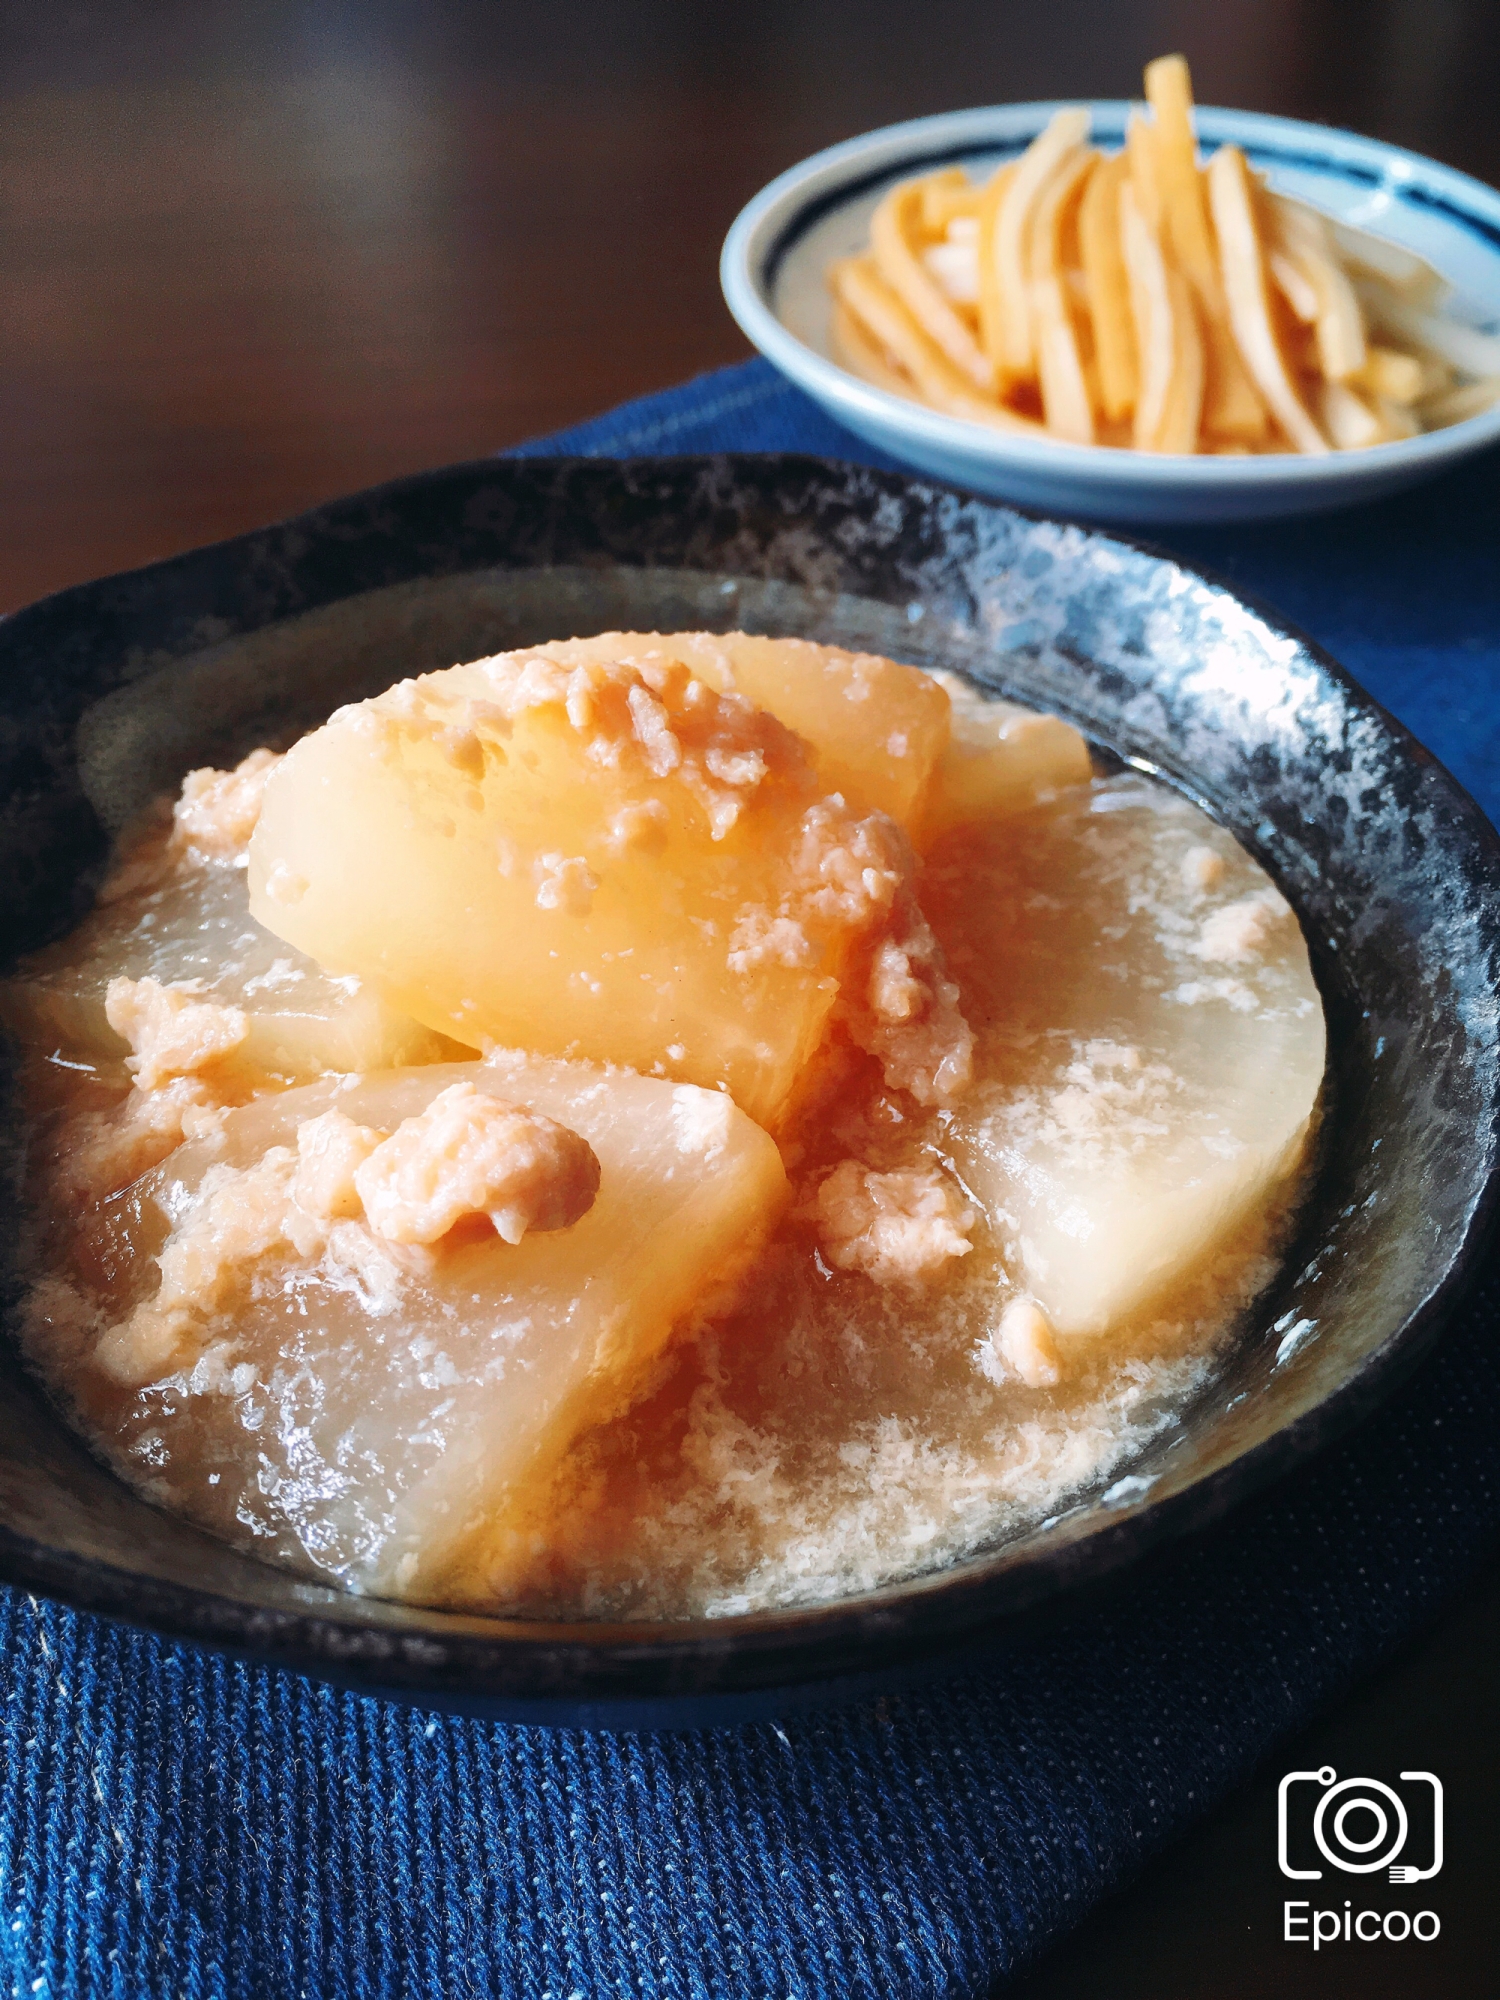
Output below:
[924,776,1324,1338]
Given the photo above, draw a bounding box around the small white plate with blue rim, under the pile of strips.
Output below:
[720,102,1500,522]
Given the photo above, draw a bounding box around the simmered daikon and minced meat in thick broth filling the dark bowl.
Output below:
[4,634,1324,1618]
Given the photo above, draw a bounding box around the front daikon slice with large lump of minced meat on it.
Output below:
[30,1054,786,1604]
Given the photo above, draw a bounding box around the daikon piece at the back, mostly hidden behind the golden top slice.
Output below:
[518,632,952,832]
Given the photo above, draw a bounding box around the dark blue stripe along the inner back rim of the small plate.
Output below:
[756,98,1500,292]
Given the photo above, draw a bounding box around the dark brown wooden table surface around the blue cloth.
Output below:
[0,0,1500,2000]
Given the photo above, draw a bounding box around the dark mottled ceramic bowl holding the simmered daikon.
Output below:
[0,458,1500,1722]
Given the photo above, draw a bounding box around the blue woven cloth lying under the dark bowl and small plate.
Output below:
[0,362,1500,2000]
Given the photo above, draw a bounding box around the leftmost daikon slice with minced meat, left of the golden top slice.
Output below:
[0,750,452,1078]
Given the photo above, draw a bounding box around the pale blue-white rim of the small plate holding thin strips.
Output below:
[718,98,1500,488]
